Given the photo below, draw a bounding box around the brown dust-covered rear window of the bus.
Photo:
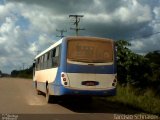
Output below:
[67,40,113,63]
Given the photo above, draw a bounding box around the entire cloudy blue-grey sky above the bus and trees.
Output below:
[0,0,160,73]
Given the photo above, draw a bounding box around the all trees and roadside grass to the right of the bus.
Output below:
[107,40,160,114]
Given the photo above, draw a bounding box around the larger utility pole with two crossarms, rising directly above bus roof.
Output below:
[69,15,85,36]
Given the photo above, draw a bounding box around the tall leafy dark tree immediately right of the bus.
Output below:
[116,40,151,87]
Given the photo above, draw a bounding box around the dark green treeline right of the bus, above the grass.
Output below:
[116,40,160,94]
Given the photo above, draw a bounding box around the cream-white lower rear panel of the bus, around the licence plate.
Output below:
[67,73,115,90]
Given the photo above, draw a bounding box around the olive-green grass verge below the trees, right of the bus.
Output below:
[107,86,160,115]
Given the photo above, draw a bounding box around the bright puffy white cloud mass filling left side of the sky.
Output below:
[0,3,63,72]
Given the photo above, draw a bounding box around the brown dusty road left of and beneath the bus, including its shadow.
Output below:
[0,78,150,120]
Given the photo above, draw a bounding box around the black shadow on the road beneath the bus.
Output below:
[50,98,140,114]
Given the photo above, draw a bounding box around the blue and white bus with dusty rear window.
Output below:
[33,36,117,103]
